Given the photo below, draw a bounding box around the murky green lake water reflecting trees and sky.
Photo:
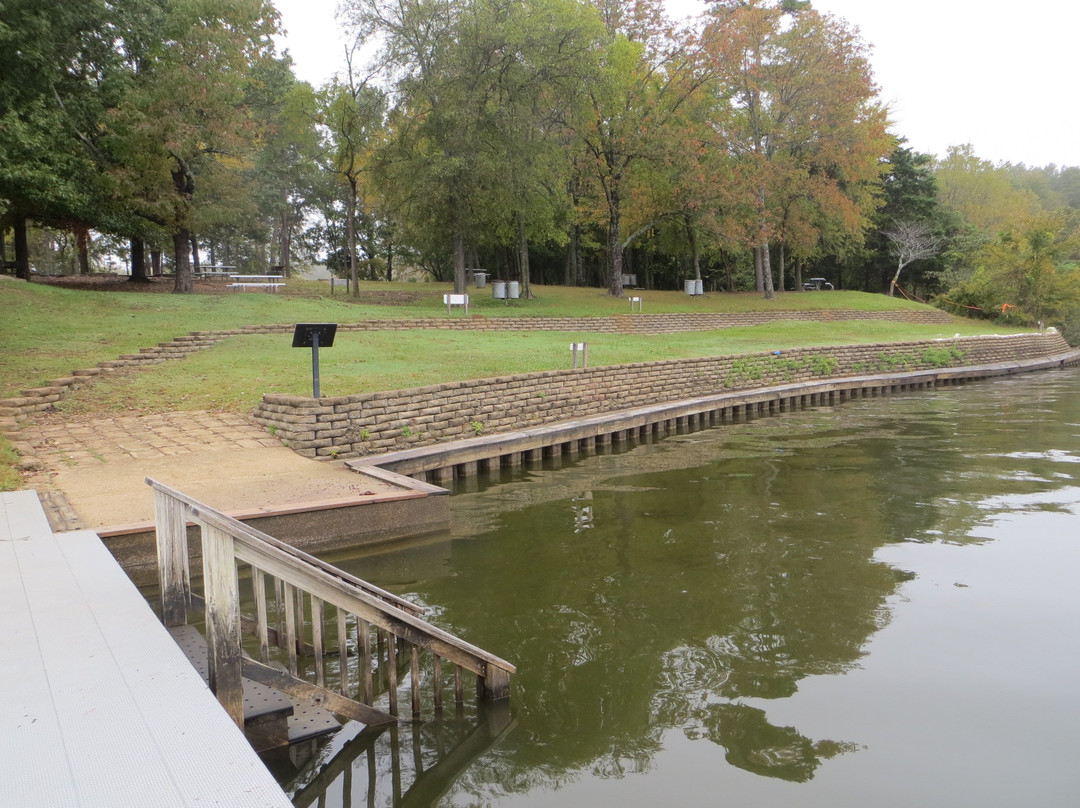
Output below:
[284,369,1080,808]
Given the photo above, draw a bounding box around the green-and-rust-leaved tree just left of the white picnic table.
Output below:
[103,0,276,293]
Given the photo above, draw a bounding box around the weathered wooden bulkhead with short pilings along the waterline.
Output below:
[347,351,1080,483]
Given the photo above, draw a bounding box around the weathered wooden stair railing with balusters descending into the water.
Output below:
[146,477,516,725]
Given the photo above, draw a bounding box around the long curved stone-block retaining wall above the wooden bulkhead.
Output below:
[255,334,1069,458]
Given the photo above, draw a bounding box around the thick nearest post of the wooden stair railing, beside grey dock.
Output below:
[200,523,244,729]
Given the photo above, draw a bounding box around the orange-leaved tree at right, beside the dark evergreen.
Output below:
[706,0,893,297]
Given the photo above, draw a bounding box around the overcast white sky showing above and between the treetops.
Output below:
[273,0,1080,165]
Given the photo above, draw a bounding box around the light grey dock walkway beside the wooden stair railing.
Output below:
[0,490,292,808]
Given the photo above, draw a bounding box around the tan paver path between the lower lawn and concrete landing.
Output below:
[19,410,281,468]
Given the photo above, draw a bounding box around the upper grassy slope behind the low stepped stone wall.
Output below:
[0,278,959,398]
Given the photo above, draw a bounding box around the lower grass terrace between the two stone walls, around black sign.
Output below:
[52,321,1019,414]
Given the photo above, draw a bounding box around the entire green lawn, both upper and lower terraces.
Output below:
[0,277,1028,490]
